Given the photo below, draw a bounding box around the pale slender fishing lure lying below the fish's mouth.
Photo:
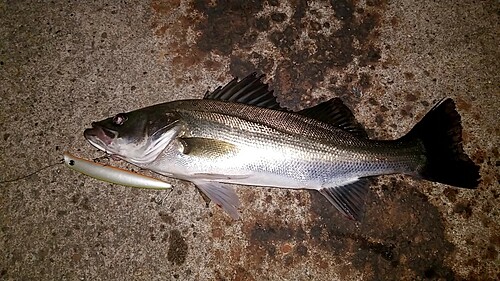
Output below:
[64,152,172,189]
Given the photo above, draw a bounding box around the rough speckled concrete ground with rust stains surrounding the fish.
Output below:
[0,0,500,280]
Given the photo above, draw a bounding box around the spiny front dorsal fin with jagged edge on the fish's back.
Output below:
[203,72,283,110]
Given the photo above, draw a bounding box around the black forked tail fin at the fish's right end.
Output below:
[403,98,480,188]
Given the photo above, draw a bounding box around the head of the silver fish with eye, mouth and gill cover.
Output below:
[84,107,181,166]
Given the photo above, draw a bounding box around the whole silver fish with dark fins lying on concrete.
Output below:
[84,73,480,221]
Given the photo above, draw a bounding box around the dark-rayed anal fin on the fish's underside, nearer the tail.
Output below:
[319,179,369,221]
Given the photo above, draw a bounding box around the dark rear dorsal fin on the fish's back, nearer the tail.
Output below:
[297,98,368,138]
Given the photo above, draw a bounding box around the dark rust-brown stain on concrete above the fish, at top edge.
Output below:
[151,0,386,109]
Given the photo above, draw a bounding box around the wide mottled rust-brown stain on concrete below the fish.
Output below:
[202,177,460,280]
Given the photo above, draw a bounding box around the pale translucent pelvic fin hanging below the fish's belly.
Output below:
[194,181,240,220]
